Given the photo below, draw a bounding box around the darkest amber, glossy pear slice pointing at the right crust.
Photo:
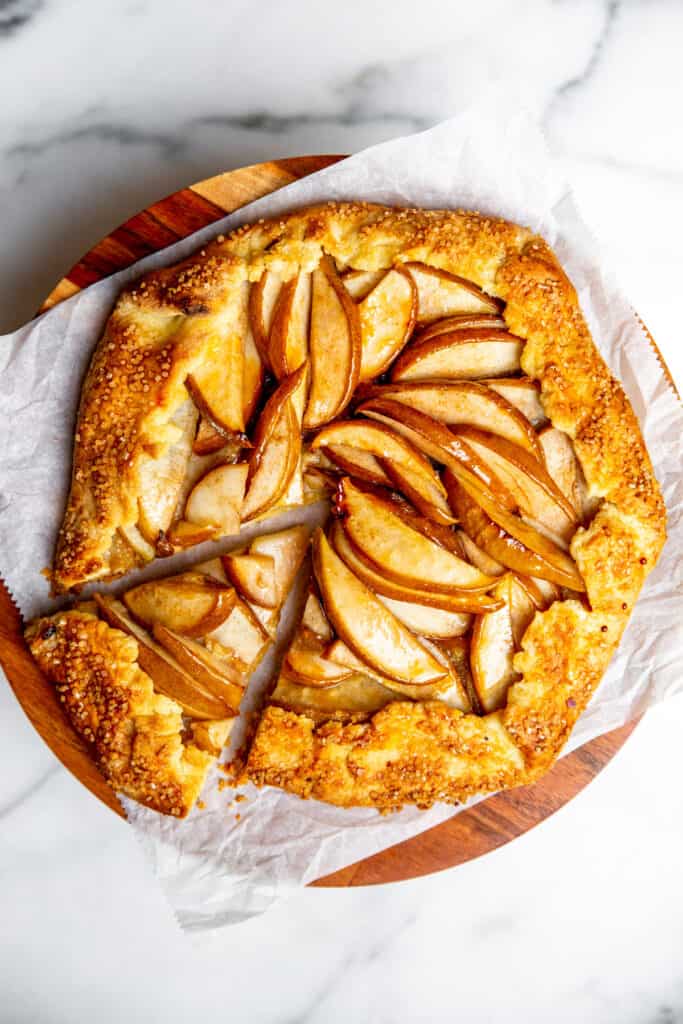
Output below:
[443,469,586,592]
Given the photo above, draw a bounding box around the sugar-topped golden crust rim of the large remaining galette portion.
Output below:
[55,203,666,809]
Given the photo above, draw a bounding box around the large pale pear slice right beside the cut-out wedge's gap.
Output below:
[313,530,445,685]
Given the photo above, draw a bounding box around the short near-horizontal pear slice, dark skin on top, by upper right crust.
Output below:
[391,329,524,381]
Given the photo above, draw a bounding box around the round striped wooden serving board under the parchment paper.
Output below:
[0,156,647,887]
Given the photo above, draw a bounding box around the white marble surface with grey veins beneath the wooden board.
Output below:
[0,0,683,1024]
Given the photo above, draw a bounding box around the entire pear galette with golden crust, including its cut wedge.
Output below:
[29,203,666,813]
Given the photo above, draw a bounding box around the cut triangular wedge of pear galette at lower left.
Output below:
[26,526,309,817]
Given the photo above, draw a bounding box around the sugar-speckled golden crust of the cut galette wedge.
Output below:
[26,611,227,817]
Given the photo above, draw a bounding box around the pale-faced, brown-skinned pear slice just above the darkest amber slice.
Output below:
[455,427,579,547]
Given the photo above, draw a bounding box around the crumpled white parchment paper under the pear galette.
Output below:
[0,94,683,931]
